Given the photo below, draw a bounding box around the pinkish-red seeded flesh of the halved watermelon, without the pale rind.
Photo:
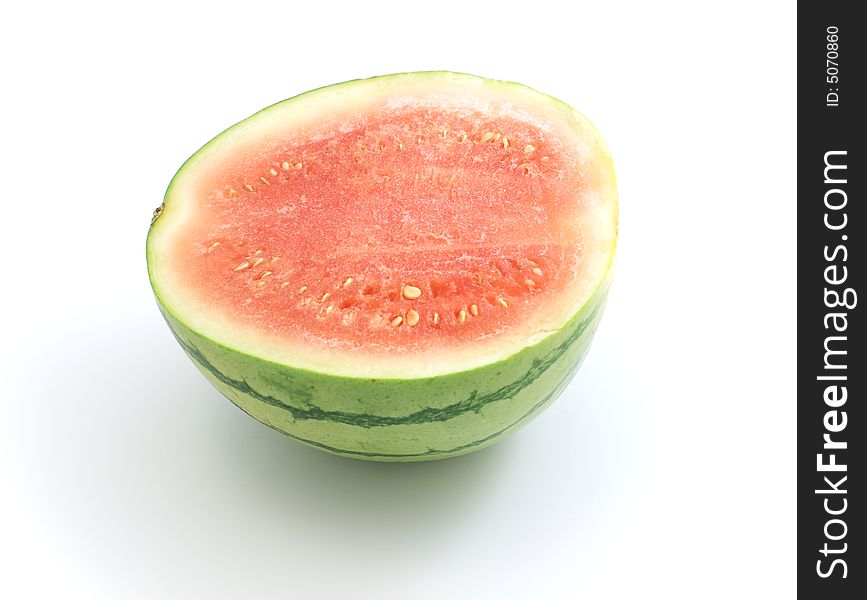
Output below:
[165,106,594,355]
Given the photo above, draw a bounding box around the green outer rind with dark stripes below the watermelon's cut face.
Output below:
[163,280,608,461]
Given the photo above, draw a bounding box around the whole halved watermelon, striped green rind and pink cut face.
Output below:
[147,72,617,461]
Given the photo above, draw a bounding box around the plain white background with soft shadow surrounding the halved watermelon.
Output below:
[0,0,795,600]
